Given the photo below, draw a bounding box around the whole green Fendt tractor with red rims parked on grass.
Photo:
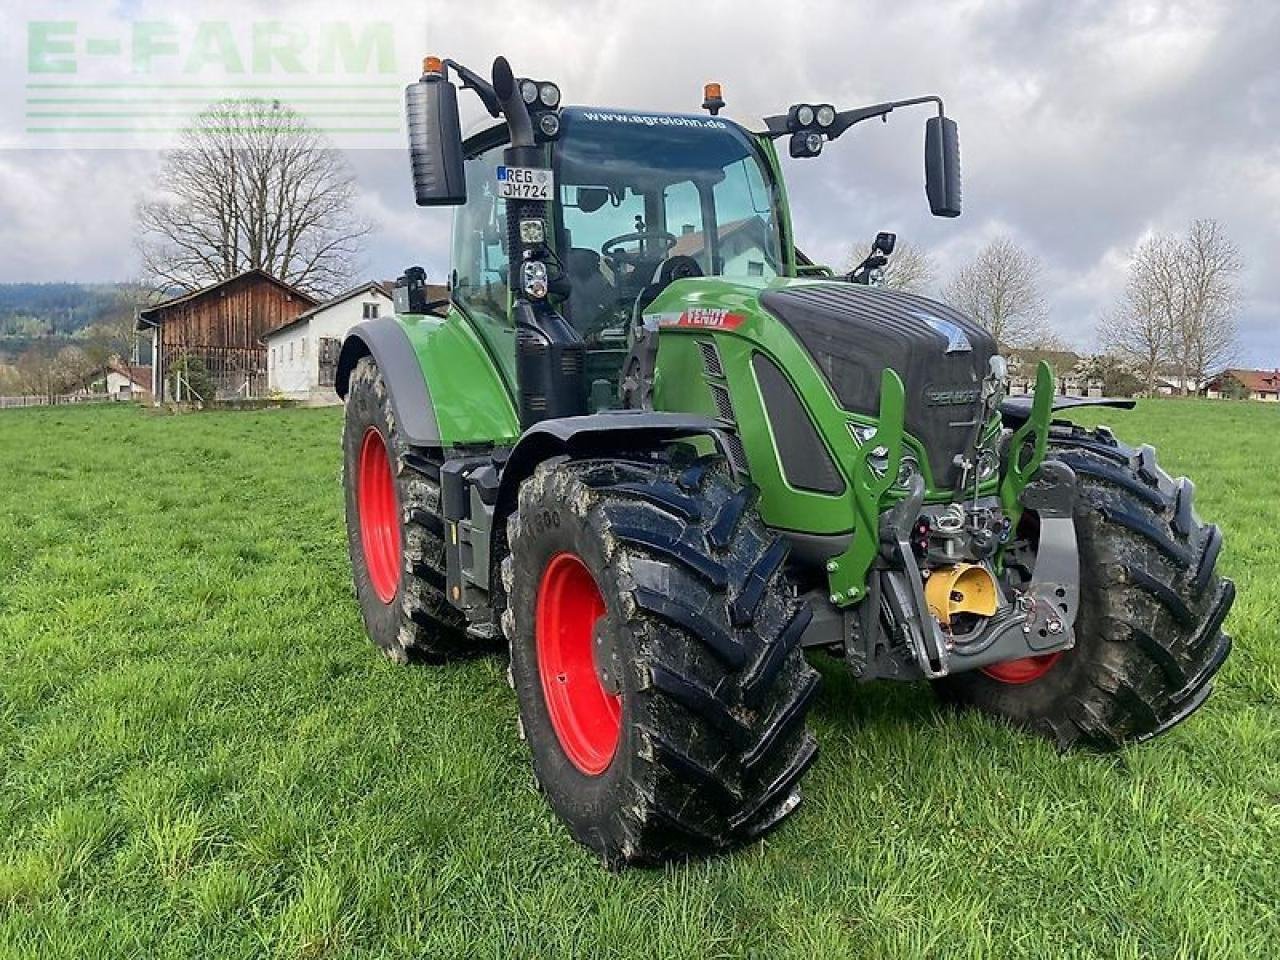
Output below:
[337,58,1234,865]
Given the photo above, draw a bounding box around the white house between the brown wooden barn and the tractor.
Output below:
[262,283,394,403]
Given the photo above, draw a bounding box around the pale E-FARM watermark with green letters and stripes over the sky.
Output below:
[8,4,424,148]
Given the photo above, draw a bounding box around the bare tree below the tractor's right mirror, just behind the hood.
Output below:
[943,237,1048,347]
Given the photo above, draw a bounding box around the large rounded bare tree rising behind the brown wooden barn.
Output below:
[137,100,369,294]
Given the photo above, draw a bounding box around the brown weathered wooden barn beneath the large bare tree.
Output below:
[138,270,316,403]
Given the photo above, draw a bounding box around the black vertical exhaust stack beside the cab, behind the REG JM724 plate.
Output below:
[493,56,586,429]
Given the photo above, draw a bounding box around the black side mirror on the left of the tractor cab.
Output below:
[404,74,467,206]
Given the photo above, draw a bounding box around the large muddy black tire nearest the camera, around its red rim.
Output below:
[503,461,818,865]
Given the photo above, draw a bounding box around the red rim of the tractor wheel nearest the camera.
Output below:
[535,553,622,777]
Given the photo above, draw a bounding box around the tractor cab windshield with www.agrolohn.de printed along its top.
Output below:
[554,109,785,343]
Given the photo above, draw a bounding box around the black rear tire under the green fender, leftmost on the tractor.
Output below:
[342,357,476,663]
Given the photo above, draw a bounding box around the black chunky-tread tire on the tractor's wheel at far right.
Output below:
[934,425,1235,749]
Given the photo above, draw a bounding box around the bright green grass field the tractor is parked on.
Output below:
[0,401,1280,960]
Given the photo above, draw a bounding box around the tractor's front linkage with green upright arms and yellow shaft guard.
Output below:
[806,362,1080,680]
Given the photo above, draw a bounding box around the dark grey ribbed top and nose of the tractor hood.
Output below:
[760,283,996,486]
